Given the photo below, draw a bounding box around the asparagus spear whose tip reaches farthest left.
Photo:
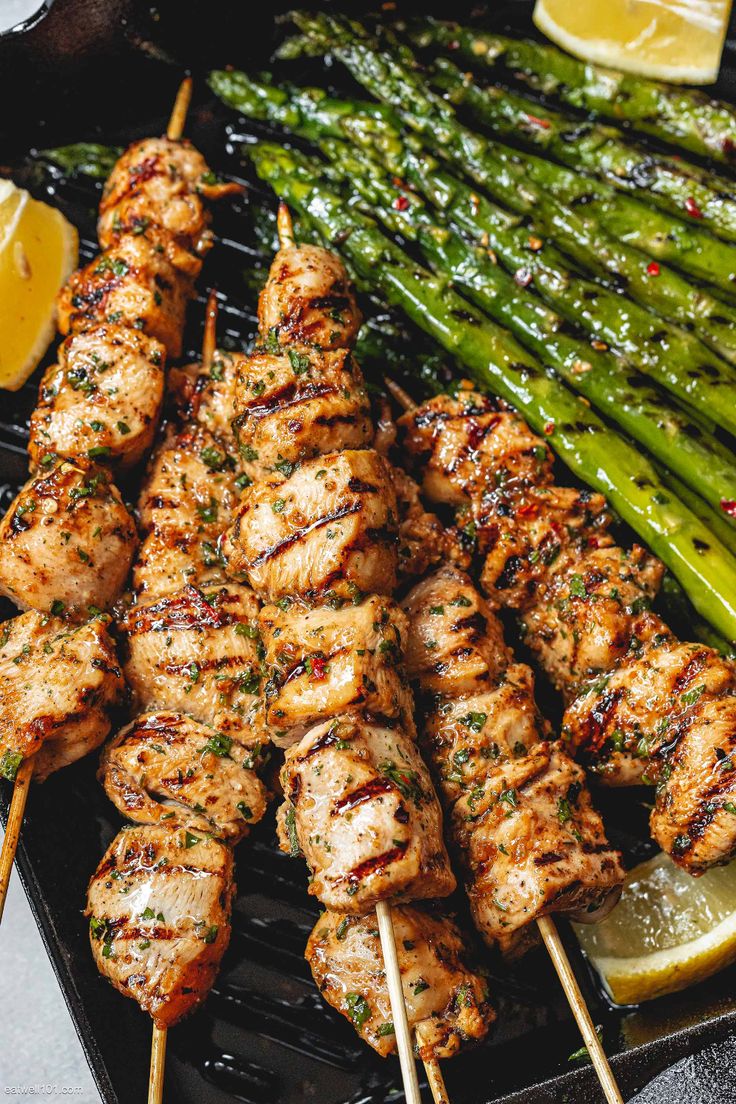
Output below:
[210,72,736,433]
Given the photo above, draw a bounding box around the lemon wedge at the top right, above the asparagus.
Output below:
[534,0,730,84]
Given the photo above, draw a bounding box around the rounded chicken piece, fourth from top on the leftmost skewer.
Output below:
[0,459,137,618]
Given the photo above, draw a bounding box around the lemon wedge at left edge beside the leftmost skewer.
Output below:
[0,180,78,391]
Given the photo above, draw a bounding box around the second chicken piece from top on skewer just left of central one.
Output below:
[134,425,243,598]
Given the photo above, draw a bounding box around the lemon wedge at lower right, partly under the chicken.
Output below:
[573,854,736,1005]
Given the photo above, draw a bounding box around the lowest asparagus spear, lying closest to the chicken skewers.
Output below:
[249,142,736,639]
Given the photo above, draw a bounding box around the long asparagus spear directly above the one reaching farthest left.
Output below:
[295,13,734,368]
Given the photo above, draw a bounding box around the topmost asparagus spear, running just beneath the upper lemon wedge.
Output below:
[414,20,736,162]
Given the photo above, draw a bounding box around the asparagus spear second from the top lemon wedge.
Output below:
[414,51,736,242]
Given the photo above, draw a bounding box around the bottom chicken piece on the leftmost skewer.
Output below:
[0,611,125,782]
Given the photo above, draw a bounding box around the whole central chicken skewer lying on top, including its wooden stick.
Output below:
[223,205,455,1104]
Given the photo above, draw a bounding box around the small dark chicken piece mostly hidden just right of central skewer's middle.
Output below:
[391,465,470,578]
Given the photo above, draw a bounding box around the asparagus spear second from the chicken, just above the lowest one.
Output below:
[322,131,736,518]
